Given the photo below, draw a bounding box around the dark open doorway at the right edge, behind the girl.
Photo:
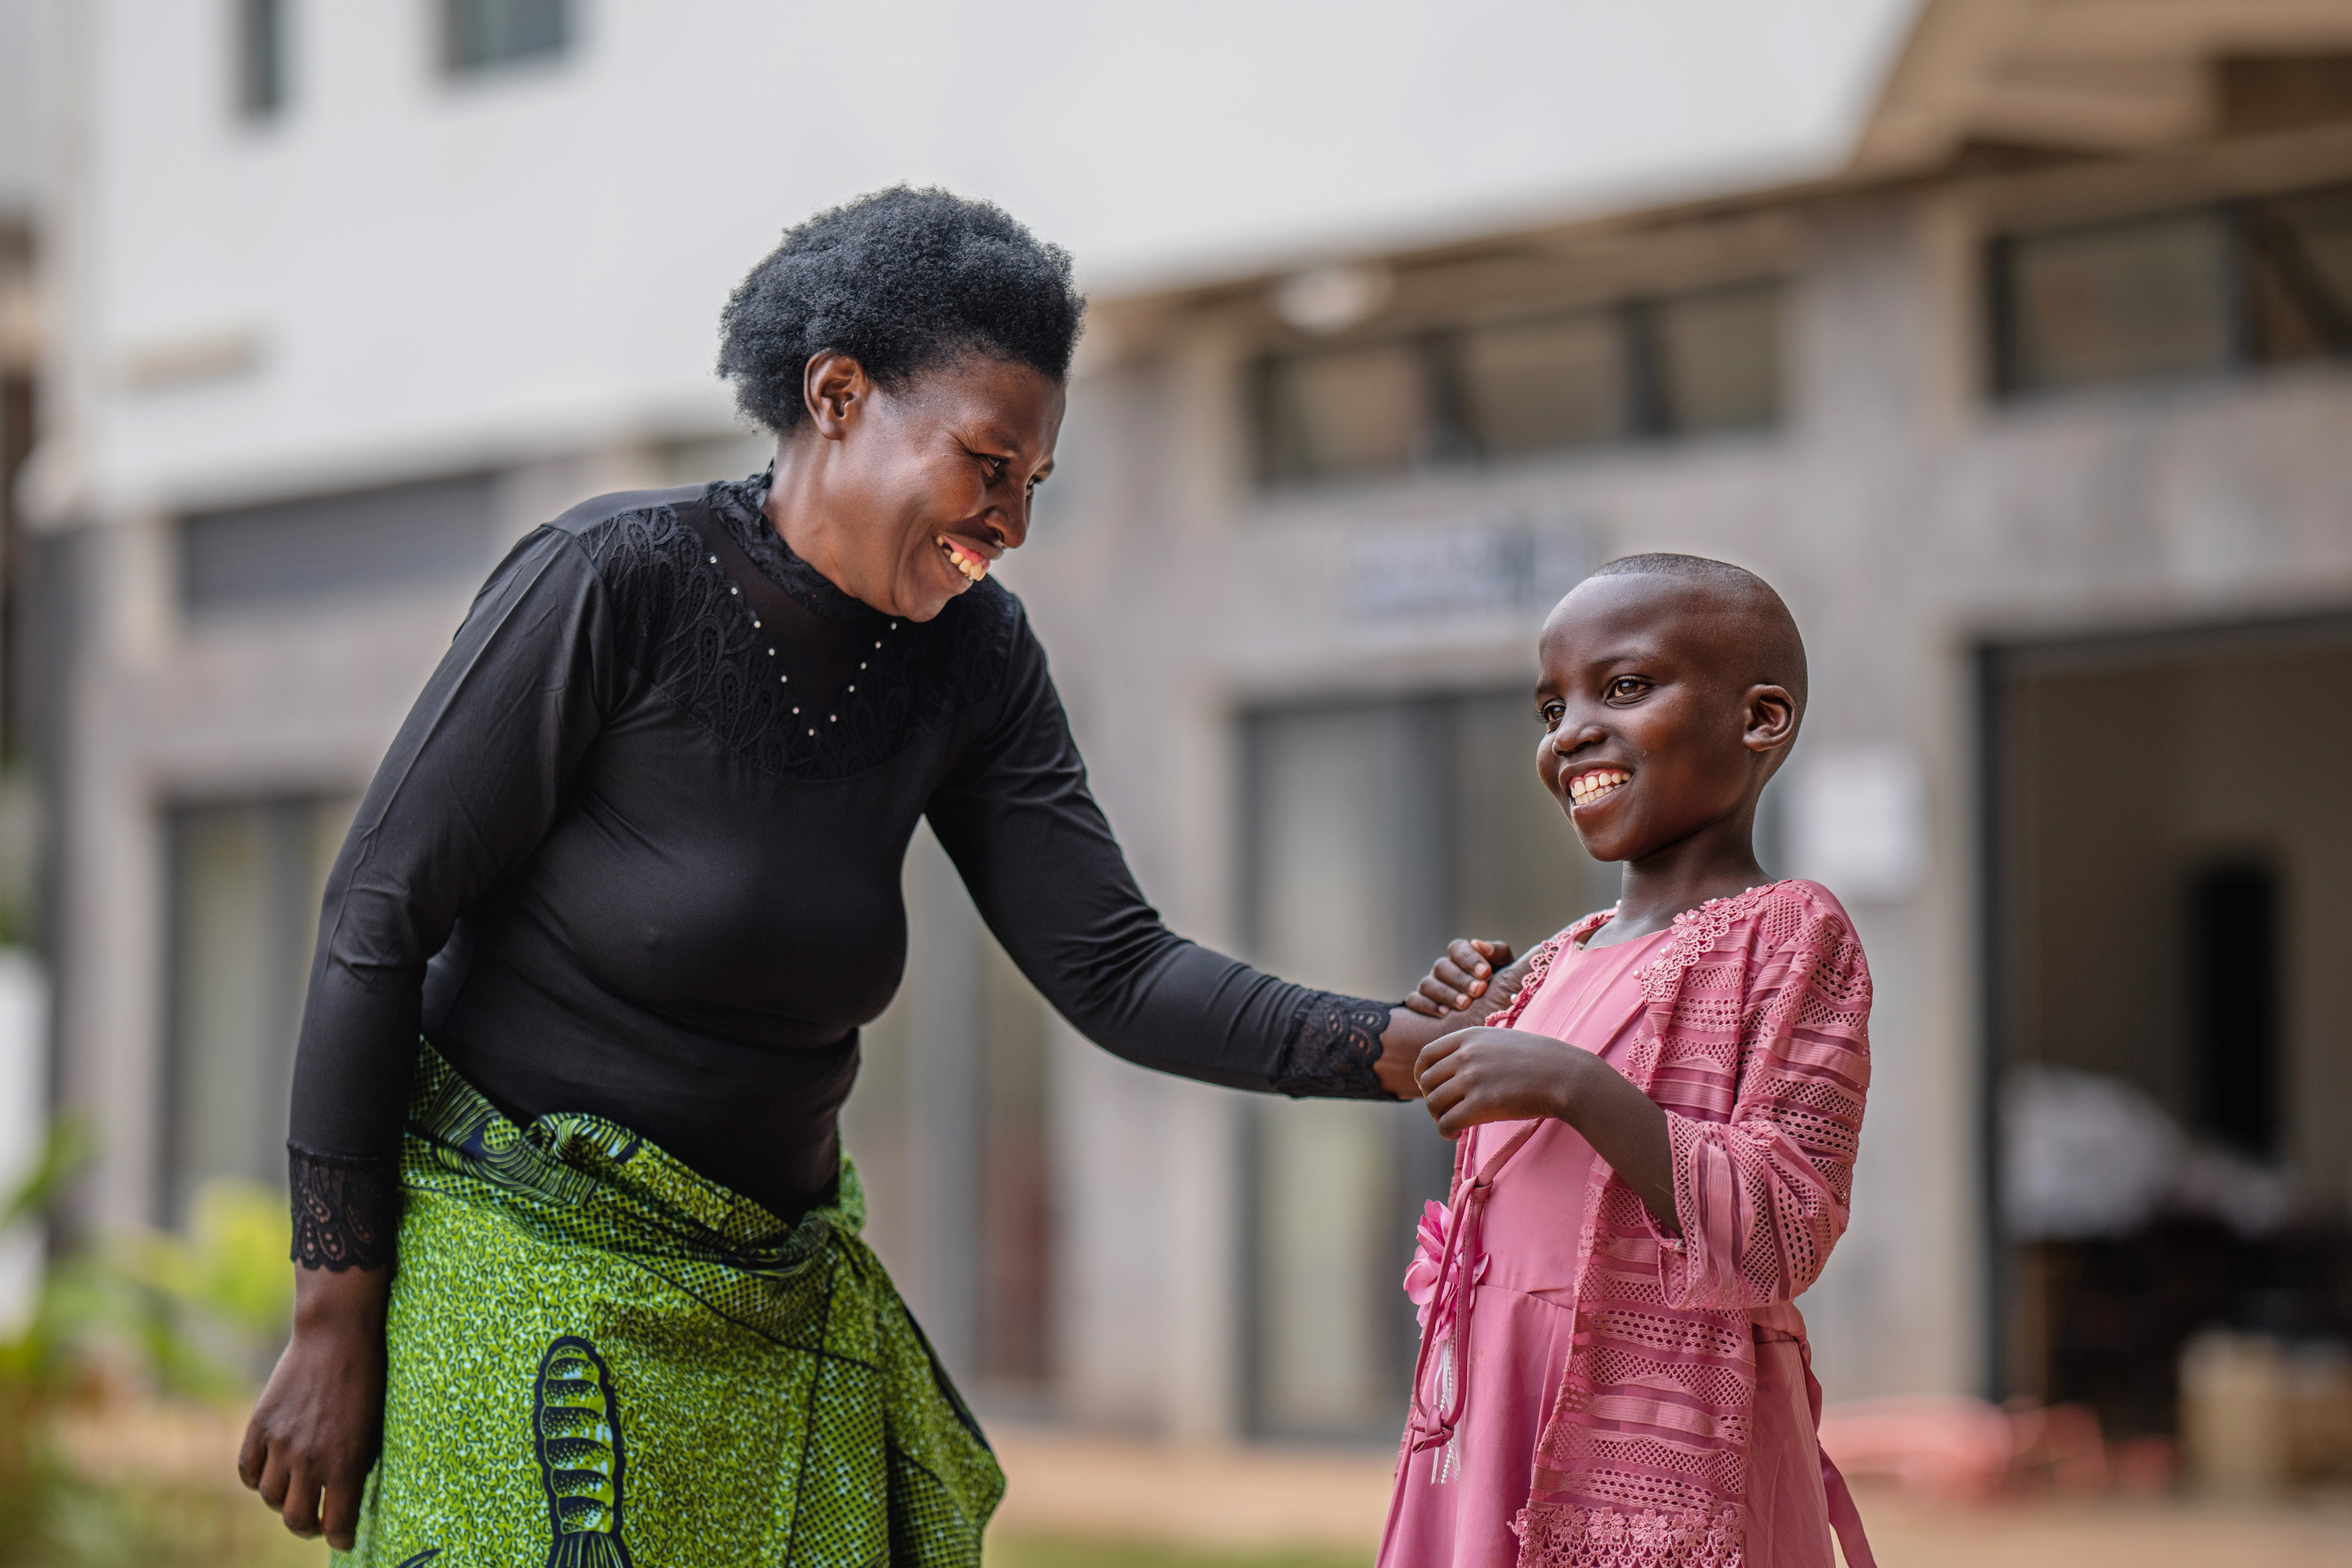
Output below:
[1980,616,2352,1439]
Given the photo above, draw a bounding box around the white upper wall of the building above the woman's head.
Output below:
[52,0,1912,510]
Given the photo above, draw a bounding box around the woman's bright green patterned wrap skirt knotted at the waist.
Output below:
[334,1048,1004,1568]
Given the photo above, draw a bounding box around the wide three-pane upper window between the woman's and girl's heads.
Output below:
[1258,282,1781,484]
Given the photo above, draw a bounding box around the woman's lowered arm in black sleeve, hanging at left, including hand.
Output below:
[237,529,611,1549]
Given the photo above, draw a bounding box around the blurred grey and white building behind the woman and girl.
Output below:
[23,0,2352,1466]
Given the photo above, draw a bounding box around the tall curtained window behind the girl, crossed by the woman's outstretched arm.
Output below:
[1242,691,1611,1441]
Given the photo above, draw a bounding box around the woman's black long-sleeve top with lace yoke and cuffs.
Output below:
[292,480,1388,1267]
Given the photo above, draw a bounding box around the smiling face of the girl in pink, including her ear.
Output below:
[1536,576,1797,860]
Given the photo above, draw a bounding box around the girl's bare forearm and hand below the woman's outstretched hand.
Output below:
[1413,1029,1682,1236]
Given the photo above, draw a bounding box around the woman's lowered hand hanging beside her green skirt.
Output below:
[237,1270,393,1551]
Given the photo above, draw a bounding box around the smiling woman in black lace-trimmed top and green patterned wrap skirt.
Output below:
[237,188,1442,1568]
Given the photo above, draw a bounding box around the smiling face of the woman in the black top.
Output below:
[769,353,1066,621]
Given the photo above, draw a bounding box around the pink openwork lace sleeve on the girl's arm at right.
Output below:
[1658,898,1870,1310]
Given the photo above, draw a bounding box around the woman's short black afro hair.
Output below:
[719,186,1087,433]
